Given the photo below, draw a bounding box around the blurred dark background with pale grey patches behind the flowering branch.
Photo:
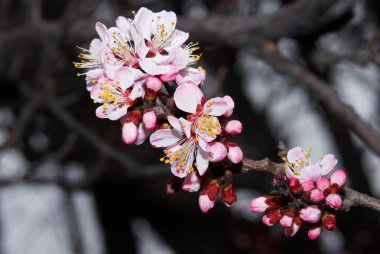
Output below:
[0,0,380,254]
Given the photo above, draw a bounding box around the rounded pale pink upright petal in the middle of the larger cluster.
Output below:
[174,84,200,113]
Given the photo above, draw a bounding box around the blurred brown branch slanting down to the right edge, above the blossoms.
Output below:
[250,43,380,156]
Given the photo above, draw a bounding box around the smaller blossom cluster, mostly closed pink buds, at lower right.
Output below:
[250,147,347,240]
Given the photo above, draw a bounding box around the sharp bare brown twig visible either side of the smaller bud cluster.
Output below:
[240,158,380,212]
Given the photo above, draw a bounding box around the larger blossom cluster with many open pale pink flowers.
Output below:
[74,8,243,212]
